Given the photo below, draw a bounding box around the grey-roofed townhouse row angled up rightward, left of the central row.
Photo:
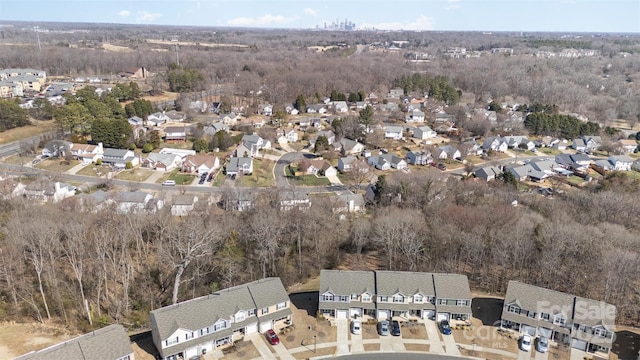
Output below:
[151,278,292,360]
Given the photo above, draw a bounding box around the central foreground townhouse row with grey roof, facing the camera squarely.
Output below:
[318,270,471,321]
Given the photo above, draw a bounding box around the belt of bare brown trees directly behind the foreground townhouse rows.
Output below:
[0,172,640,330]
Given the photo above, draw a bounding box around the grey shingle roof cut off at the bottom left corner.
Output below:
[14,324,135,360]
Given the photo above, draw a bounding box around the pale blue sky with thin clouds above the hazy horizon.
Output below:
[0,0,640,33]
